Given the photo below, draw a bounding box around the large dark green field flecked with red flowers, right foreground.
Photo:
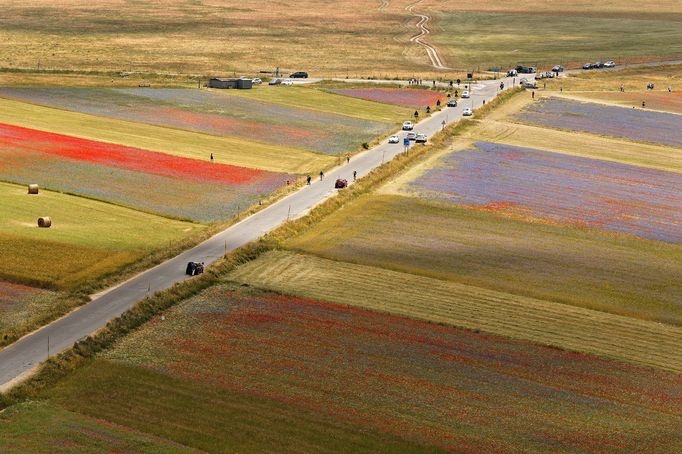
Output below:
[45,284,682,452]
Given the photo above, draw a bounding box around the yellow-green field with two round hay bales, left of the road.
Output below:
[0,183,205,288]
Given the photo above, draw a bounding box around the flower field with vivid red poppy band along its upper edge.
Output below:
[0,124,295,222]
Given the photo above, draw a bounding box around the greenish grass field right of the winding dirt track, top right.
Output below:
[432,10,682,70]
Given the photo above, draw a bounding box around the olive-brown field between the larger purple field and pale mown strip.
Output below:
[288,195,682,325]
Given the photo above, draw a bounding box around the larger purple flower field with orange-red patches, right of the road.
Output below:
[406,142,682,243]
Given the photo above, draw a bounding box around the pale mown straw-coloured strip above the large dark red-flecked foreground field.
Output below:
[228,250,682,373]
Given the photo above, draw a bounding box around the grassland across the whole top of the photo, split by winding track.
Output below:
[0,0,682,74]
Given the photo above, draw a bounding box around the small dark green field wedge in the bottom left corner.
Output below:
[0,401,195,454]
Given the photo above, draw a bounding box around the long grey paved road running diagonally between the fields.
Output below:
[0,74,511,389]
